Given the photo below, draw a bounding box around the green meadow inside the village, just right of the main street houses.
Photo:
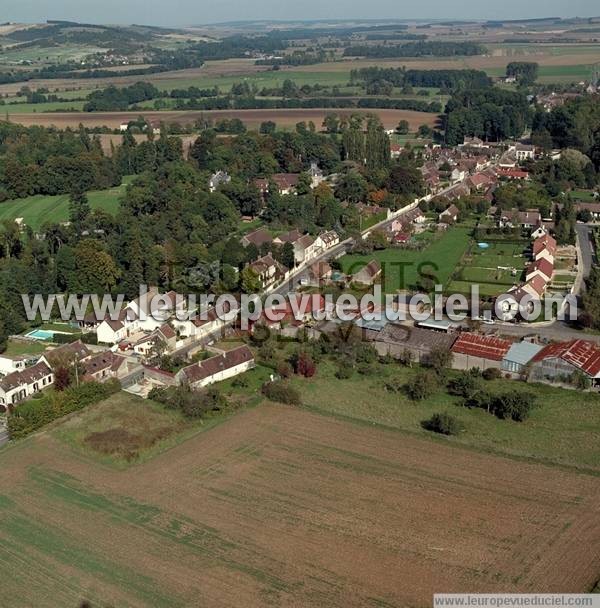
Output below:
[340,226,471,294]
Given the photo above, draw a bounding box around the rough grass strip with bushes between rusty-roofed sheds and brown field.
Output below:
[292,361,600,475]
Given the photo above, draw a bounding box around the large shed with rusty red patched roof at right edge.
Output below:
[530,340,600,386]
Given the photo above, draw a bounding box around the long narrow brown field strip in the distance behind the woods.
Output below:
[9,108,438,131]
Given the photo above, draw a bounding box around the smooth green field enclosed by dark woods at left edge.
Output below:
[0,176,133,230]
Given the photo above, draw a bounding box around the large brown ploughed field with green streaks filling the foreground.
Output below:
[0,404,600,608]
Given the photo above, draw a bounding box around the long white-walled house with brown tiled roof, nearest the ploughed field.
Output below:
[175,346,255,389]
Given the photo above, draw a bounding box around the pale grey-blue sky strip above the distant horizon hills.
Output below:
[0,0,600,26]
